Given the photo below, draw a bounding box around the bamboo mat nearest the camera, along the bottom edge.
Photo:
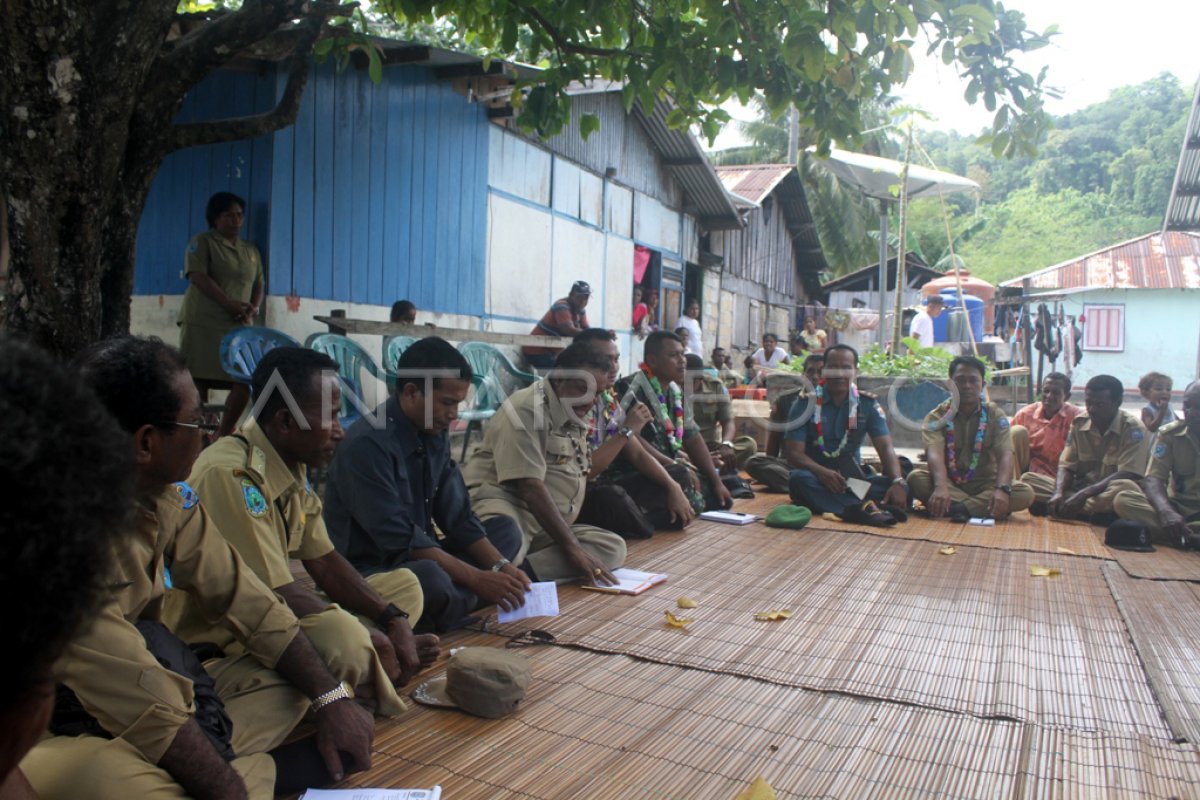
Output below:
[331,648,1200,800]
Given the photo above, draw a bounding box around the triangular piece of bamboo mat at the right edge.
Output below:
[1104,564,1200,744]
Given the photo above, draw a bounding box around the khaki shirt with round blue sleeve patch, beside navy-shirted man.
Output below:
[164,420,334,648]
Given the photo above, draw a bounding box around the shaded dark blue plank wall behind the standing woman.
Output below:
[133,67,276,295]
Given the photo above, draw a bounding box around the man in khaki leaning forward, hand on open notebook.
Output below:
[463,343,625,583]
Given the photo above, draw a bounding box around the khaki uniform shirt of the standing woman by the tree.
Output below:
[179,230,263,327]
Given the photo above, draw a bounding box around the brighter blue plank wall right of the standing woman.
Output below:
[268,66,488,314]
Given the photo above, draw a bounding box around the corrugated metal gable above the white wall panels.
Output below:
[547,92,683,209]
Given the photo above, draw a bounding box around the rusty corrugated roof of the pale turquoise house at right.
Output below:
[1001,230,1200,291]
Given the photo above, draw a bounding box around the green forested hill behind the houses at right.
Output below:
[910,74,1192,282]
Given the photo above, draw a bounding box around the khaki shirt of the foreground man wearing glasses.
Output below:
[55,483,299,763]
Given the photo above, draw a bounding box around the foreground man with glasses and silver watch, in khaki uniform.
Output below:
[22,337,378,800]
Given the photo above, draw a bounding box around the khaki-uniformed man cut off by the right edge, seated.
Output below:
[1112,381,1200,547]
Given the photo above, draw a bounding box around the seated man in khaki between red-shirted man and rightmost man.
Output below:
[1021,375,1150,524]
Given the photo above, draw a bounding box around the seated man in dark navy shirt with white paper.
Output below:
[325,336,529,631]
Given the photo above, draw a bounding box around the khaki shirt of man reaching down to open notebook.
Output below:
[463,380,592,525]
